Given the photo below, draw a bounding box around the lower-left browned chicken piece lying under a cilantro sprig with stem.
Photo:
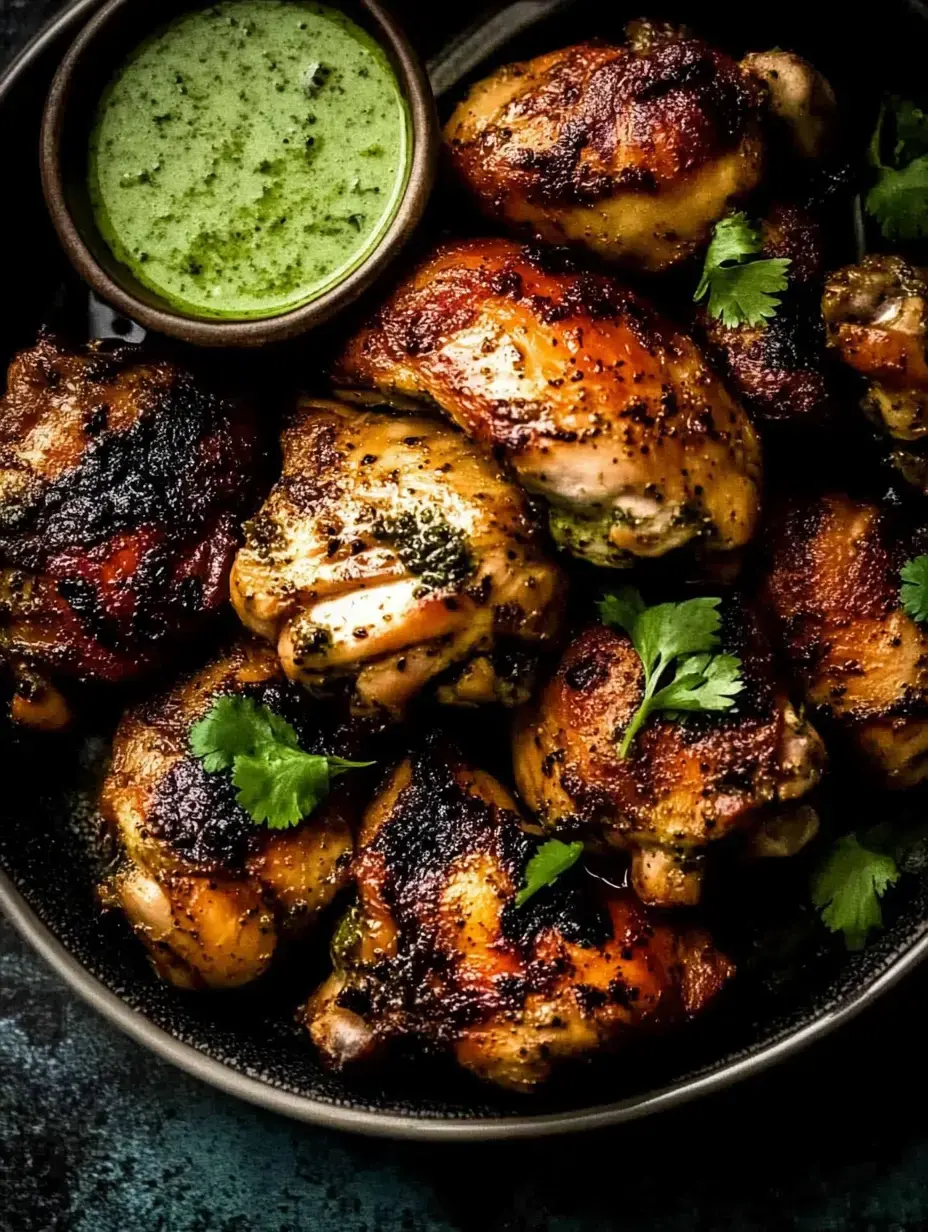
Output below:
[100,641,355,988]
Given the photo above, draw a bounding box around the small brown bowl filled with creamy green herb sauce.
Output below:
[41,0,438,346]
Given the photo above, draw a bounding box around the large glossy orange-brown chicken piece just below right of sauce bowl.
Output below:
[335,239,760,565]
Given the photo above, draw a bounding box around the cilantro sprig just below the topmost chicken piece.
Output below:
[693,213,790,328]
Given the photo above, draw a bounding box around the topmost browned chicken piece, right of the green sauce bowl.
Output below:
[445,22,765,271]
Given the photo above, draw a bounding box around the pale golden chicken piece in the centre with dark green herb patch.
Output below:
[232,402,563,717]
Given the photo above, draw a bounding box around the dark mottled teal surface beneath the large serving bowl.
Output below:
[0,0,928,1232]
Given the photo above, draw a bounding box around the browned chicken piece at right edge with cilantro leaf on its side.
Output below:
[764,493,928,787]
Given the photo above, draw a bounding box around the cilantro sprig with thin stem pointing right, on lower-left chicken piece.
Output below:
[190,695,373,830]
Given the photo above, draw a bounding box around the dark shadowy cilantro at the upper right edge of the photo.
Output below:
[864,97,928,240]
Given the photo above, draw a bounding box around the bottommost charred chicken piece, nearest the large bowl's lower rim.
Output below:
[306,738,732,1092]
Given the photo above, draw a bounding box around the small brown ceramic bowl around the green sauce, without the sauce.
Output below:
[41,0,439,346]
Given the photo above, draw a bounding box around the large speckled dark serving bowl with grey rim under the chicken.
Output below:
[0,0,928,1140]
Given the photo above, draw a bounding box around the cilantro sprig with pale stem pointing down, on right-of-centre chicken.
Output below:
[598,586,744,758]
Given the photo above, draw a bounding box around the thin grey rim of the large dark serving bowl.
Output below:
[0,0,928,1142]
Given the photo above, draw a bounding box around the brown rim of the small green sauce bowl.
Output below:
[38,0,440,347]
